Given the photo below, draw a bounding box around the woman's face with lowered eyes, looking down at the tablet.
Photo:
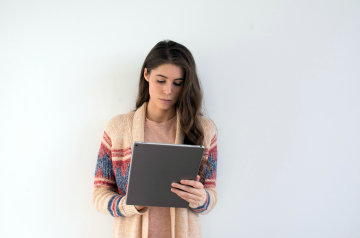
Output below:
[144,64,184,110]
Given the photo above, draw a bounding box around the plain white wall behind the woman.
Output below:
[0,0,360,238]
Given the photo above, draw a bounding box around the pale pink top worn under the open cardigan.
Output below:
[144,115,177,238]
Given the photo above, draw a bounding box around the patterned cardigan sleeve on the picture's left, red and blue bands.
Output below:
[91,119,148,217]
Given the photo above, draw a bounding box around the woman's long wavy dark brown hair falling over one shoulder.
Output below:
[134,40,211,183]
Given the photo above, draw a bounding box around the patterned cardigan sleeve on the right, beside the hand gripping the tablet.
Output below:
[189,125,217,215]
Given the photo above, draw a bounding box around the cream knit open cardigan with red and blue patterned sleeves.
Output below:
[91,102,217,238]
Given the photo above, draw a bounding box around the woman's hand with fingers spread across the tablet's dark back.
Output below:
[171,175,205,204]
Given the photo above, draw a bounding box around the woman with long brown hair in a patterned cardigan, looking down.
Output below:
[92,41,217,238]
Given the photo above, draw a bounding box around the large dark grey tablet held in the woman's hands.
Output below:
[125,141,205,208]
